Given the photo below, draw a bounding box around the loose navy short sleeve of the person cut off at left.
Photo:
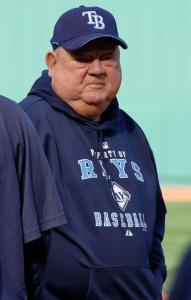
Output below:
[13,104,66,243]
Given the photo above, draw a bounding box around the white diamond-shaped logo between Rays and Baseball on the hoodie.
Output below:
[112,181,131,211]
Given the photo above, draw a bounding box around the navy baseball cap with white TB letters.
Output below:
[50,6,128,51]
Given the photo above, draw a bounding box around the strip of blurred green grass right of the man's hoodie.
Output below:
[163,201,191,292]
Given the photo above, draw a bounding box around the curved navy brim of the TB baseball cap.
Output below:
[52,33,128,51]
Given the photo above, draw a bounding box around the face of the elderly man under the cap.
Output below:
[47,38,121,120]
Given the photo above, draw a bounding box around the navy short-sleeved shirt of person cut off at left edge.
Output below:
[0,96,66,300]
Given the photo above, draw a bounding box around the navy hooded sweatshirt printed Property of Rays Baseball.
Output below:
[21,71,166,300]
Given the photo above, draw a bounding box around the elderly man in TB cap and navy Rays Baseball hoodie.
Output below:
[21,6,166,300]
